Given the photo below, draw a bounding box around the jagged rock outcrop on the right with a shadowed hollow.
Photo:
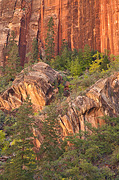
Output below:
[60,73,119,136]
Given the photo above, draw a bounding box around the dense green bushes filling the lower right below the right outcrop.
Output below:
[38,117,119,180]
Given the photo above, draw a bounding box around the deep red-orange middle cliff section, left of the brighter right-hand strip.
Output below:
[39,0,101,52]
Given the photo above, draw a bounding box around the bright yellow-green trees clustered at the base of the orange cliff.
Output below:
[51,44,93,76]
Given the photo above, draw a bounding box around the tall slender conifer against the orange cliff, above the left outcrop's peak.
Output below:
[45,17,55,62]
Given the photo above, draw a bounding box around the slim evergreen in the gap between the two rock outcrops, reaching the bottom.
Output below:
[39,104,64,179]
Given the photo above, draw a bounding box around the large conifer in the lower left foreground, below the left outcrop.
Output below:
[3,99,36,180]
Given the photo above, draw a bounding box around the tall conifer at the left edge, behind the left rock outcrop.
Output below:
[0,31,22,92]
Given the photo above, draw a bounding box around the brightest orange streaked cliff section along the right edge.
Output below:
[100,0,119,55]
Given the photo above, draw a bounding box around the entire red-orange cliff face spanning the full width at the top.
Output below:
[0,0,119,65]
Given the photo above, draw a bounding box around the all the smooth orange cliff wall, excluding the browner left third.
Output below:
[39,0,119,55]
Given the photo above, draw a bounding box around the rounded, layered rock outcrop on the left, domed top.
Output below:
[0,62,60,111]
